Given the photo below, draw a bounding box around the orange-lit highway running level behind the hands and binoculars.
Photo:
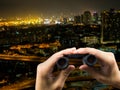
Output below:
[0,54,120,67]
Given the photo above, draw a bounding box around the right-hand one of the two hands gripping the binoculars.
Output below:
[75,48,120,88]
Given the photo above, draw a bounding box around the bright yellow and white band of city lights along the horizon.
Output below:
[0,16,73,26]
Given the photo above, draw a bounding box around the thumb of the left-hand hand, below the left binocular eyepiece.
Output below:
[56,65,75,86]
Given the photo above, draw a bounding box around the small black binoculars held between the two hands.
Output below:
[56,54,97,70]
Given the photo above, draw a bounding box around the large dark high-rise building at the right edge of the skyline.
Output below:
[101,9,120,43]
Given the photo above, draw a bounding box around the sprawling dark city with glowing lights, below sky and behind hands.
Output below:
[0,9,120,90]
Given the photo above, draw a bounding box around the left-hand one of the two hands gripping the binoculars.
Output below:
[35,48,76,90]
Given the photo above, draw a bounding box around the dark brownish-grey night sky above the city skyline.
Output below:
[0,0,120,16]
